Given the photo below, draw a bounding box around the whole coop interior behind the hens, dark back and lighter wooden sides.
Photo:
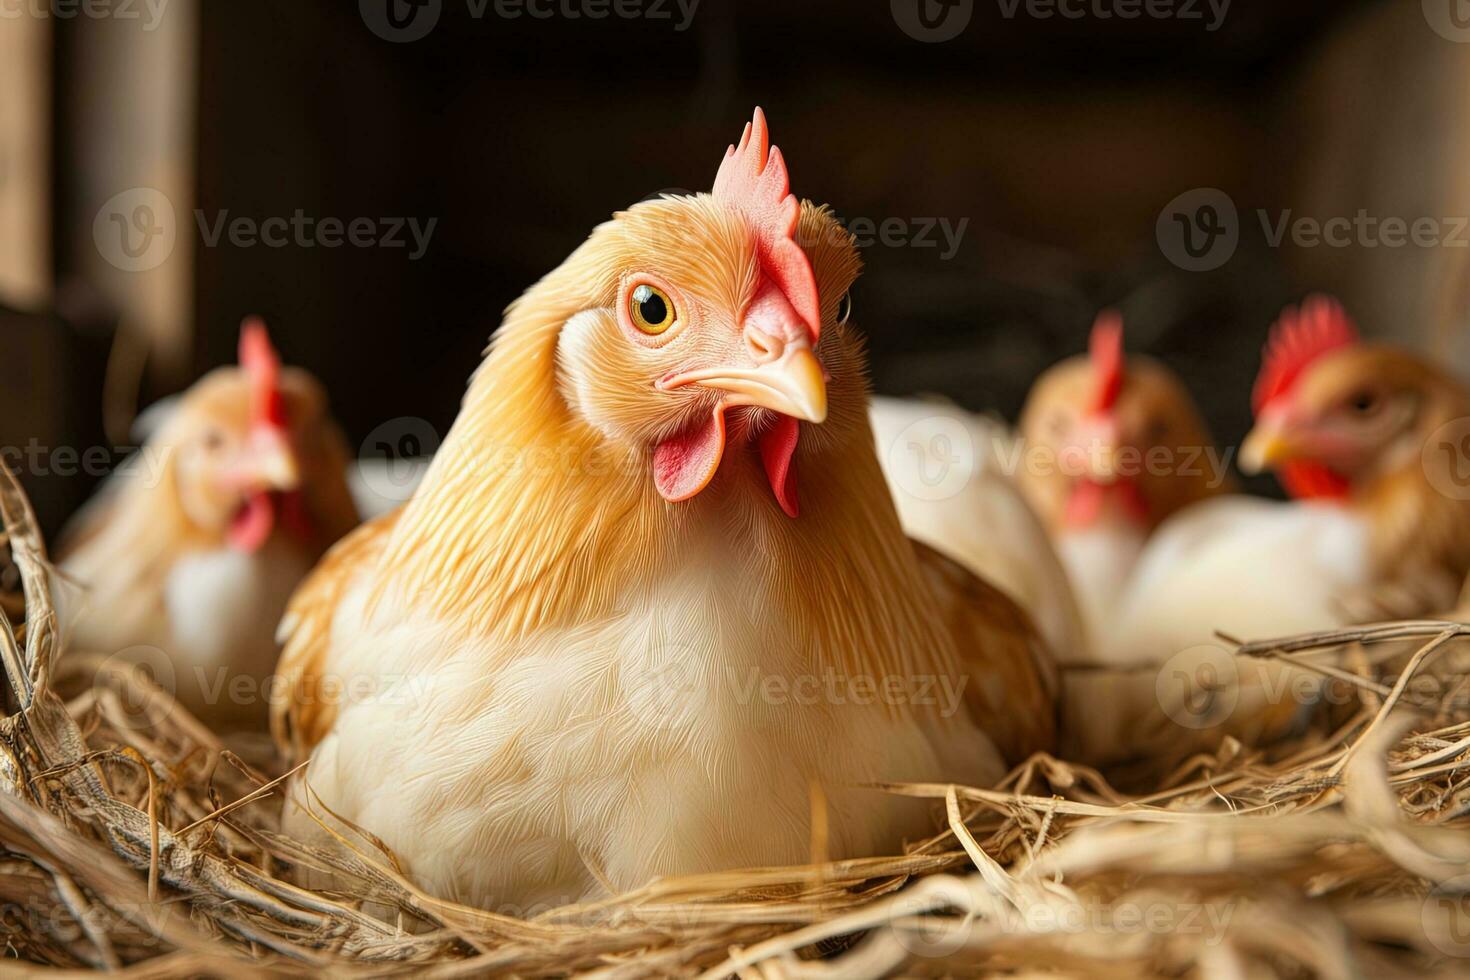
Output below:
[0,0,1470,532]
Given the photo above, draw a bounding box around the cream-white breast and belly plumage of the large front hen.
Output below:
[285,525,1004,914]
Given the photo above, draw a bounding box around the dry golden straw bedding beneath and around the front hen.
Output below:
[0,461,1470,977]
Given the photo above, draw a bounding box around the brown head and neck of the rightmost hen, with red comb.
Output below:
[1241,297,1470,619]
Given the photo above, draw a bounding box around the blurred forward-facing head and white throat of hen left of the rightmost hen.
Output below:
[1016,311,1229,654]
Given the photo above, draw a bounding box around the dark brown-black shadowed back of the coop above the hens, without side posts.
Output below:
[11,0,1464,537]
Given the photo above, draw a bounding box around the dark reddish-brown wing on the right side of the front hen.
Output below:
[913,541,1057,764]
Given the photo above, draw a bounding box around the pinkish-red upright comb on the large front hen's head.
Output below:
[711,106,822,339]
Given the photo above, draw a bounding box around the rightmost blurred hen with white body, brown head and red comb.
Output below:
[1081,297,1470,764]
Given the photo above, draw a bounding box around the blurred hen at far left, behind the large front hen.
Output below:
[57,320,357,730]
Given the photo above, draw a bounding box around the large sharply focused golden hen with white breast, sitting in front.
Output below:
[278,110,1053,907]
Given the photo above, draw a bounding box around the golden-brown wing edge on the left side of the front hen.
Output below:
[270,510,401,758]
